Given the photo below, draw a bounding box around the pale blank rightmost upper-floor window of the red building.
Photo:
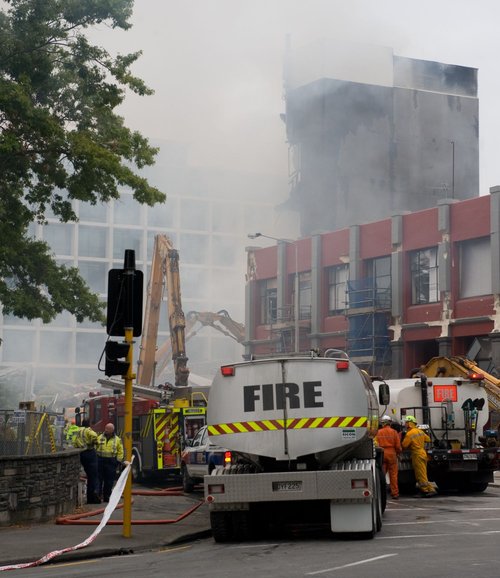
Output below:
[460,237,491,298]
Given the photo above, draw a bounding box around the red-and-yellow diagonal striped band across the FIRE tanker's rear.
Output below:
[208,416,368,436]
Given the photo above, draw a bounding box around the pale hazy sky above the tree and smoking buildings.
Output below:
[93,0,500,194]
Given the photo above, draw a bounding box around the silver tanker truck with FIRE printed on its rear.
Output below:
[204,350,388,542]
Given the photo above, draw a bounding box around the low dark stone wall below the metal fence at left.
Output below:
[0,450,80,526]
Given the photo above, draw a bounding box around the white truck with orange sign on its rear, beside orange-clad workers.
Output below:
[374,372,500,492]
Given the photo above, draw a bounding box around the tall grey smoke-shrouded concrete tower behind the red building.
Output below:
[284,43,479,235]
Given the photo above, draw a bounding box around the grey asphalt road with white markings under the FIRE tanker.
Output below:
[8,487,500,578]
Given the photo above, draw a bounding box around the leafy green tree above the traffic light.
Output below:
[0,0,165,322]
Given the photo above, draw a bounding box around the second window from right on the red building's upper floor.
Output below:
[410,247,439,305]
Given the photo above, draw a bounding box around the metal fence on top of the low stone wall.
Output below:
[0,409,65,456]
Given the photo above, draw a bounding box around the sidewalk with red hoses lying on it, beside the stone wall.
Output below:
[0,487,211,567]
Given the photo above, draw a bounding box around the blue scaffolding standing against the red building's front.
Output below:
[346,278,391,376]
